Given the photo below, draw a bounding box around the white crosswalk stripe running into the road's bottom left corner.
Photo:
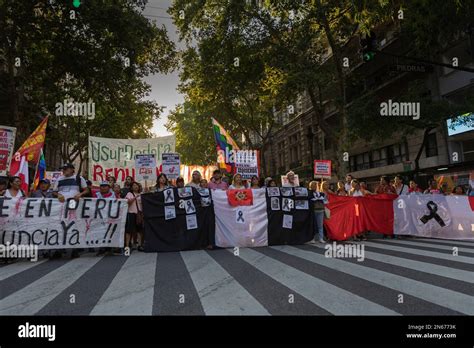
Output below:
[0,256,101,315]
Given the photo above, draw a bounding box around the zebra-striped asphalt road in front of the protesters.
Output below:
[0,238,474,315]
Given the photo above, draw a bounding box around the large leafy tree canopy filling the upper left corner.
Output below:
[0,0,176,169]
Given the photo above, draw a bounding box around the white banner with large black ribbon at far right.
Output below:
[393,194,474,240]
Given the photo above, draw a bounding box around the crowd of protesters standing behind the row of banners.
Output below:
[0,163,474,257]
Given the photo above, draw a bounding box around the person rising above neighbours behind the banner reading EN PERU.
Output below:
[53,163,89,202]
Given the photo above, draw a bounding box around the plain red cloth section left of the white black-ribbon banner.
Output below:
[324,194,398,240]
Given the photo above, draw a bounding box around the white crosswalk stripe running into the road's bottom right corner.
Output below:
[272,246,474,315]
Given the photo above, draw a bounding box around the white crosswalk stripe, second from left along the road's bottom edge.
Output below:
[91,253,157,315]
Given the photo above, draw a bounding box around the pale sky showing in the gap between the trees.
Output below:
[143,0,184,136]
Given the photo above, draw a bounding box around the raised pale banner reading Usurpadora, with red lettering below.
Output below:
[89,135,176,185]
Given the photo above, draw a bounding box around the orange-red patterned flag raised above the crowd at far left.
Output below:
[10,117,48,173]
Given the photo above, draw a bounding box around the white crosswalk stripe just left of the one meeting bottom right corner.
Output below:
[235,248,398,315]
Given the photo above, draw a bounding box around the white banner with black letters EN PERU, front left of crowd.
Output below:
[0,197,128,249]
